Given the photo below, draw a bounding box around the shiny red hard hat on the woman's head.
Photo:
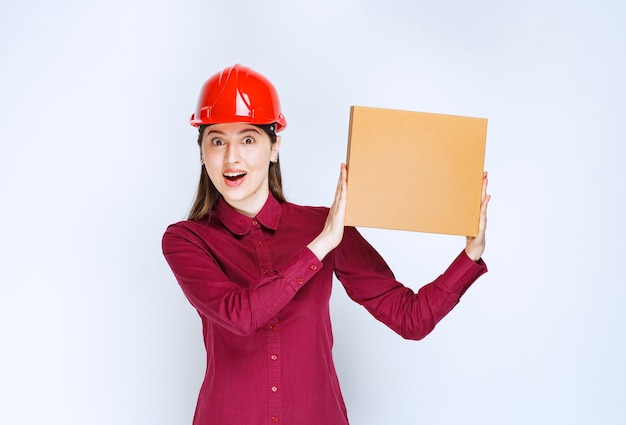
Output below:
[190,64,287,132]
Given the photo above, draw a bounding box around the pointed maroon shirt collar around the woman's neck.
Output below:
[215,193,282,236]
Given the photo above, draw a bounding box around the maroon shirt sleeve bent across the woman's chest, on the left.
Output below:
[162,225,322,336]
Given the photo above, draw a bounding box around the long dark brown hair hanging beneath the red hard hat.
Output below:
[188,124,285,220]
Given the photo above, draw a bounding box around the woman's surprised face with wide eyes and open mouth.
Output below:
[201,123,280,217]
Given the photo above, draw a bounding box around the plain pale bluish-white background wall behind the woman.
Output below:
[0,0,626,425]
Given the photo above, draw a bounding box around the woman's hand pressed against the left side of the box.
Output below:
[307,164,348,261]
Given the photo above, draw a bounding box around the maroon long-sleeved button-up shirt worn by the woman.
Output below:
[163,195,487,425]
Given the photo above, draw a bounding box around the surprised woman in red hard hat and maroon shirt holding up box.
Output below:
[163,65,489,425]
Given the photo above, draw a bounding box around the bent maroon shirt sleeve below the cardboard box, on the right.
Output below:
[334,227,487,340]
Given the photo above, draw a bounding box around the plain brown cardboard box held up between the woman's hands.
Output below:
[346,106,487,236]
